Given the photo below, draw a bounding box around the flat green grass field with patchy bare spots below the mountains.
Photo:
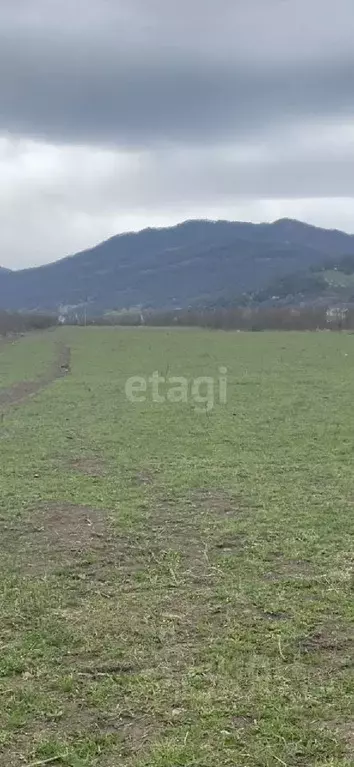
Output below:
[0,328,354,767]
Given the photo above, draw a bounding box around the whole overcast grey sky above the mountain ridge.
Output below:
[0,0,354,268]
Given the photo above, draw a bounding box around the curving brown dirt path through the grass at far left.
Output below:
[0,343,71,410]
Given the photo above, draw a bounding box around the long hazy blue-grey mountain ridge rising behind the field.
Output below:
[0,219,354,314]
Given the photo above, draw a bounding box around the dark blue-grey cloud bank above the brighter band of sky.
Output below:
[0,0,354,148]
